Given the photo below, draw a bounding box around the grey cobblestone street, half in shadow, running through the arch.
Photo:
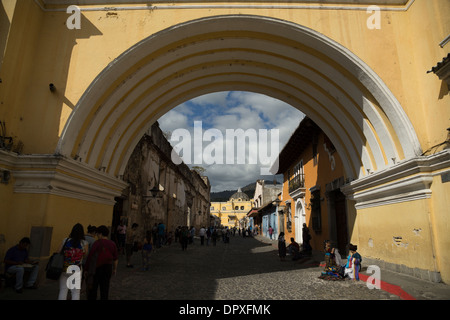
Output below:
[0,235,450,303]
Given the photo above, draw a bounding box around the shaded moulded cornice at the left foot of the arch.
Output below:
[0,151,127,205]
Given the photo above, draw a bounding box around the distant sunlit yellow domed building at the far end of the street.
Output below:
[211,188,253,228]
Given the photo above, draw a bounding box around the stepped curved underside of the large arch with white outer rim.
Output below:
[57,15,420,179]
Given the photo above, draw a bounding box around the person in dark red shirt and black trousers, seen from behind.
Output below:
[86,226,119,300]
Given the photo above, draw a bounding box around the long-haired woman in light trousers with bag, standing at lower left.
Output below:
[58,223,89,300]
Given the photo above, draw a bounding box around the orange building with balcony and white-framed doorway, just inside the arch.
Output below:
[278,117,354,253]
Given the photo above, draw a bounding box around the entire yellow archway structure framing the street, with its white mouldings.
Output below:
[0,0,450,283]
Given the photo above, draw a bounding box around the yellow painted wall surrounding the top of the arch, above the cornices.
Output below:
[0,0,450,158]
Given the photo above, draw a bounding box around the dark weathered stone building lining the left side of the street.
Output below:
[113,122,211,236]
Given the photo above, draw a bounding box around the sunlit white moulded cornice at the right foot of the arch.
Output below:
[341,149,450,209]
